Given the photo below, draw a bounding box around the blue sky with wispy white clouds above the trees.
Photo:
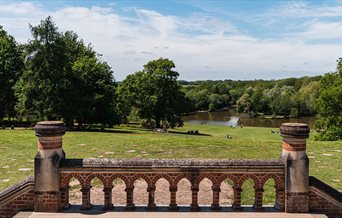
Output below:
[0,0,342,81]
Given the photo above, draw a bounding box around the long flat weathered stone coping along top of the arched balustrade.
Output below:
[60,158,285,169]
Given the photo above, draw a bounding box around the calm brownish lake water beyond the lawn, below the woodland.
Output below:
[183,109,315,128]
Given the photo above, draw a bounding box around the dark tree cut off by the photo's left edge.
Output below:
[0,26,24,121]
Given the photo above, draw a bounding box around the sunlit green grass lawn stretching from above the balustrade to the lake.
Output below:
[0,124,342,204]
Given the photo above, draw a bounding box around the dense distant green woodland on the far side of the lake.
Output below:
[182,76,321,117]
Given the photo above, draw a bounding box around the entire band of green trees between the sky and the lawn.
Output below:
[0,17,342,140]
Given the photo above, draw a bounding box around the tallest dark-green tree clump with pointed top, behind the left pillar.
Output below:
[16,17,116,128]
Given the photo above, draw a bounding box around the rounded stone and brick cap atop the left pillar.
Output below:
[34,121,66,137]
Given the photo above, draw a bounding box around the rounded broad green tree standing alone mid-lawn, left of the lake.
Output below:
[118,58,189,128]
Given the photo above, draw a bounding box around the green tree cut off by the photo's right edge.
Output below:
[315,58,342,140]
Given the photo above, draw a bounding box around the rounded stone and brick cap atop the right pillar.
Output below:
[280,123,310,138]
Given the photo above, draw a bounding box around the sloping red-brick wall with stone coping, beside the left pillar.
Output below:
[0,177,34,218]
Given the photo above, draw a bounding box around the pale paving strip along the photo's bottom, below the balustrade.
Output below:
[14,211,327,218]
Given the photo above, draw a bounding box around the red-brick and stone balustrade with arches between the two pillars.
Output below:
[59,159,285,211]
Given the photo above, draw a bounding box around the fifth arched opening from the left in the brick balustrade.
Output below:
[154,178,171,206]
